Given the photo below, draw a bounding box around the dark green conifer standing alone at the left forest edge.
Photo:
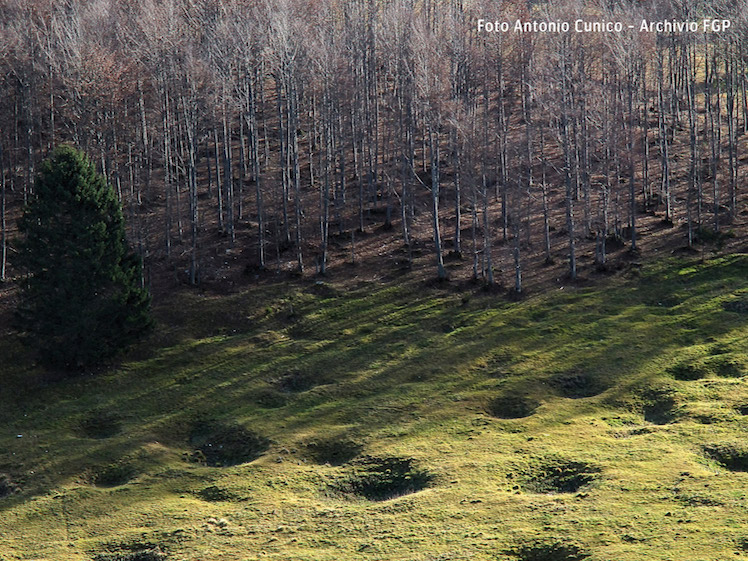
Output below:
[16,146,152,370]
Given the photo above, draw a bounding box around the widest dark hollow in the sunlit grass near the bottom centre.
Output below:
[330,456,434,501]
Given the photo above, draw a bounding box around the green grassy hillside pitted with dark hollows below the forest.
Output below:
[0,255,748,561]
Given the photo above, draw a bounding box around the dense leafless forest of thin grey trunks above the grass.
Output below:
[0,0,748,293]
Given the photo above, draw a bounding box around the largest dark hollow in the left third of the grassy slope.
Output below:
[190,421,270,467]
